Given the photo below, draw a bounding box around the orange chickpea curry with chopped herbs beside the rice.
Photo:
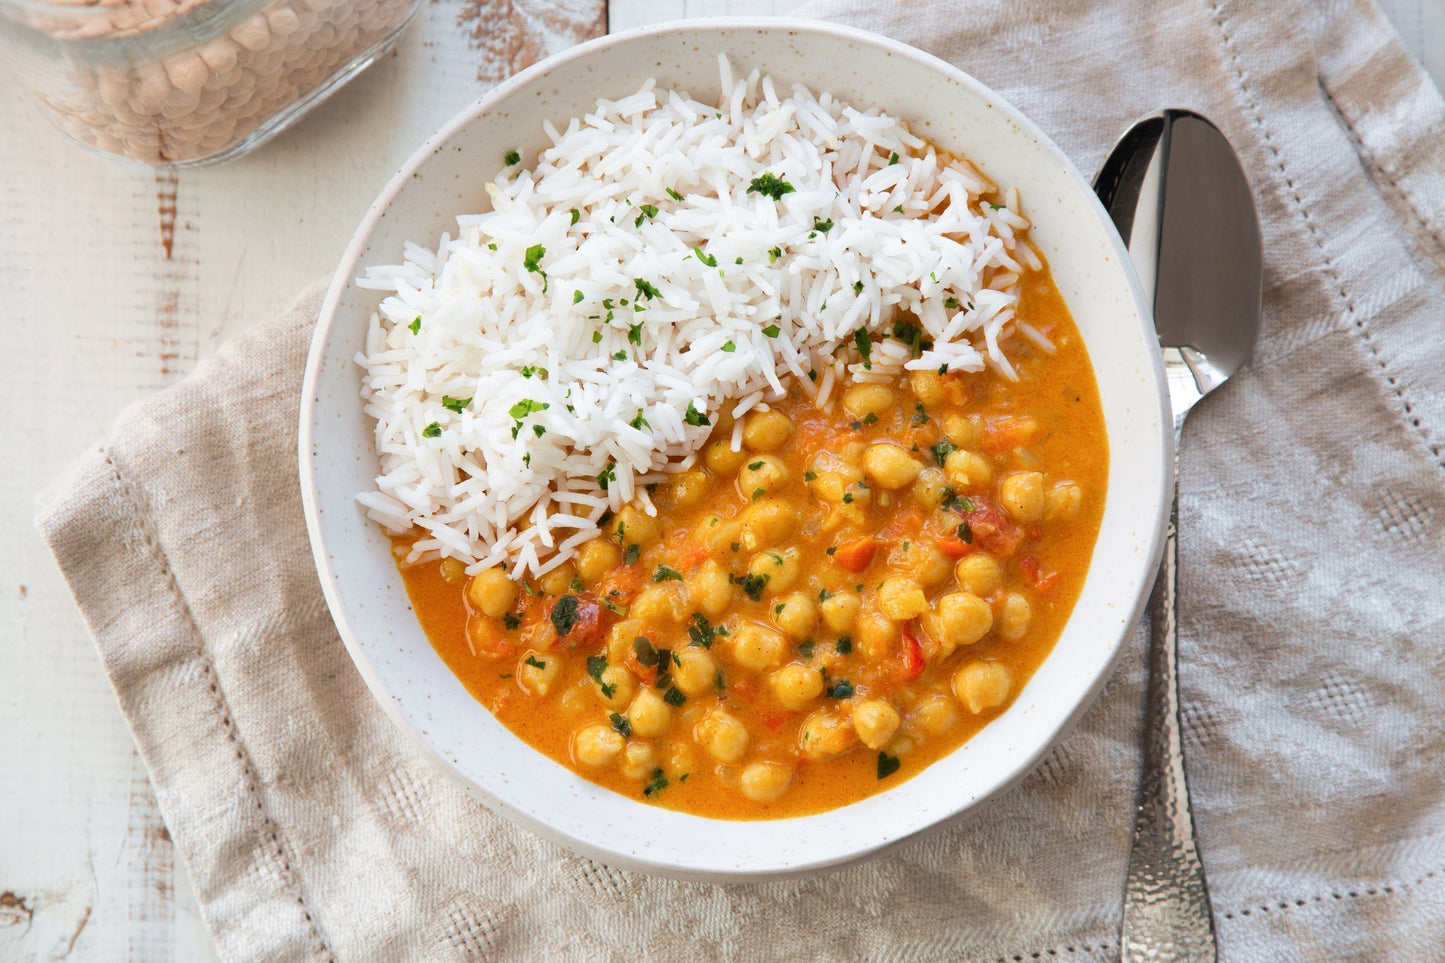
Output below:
[403,270,1108,818]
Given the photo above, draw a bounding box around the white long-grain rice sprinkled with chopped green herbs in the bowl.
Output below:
[357,59,1042,574]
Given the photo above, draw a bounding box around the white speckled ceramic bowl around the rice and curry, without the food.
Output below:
[299,20,1170,881]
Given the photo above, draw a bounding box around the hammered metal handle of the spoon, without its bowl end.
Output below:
[1120,439,1217,963]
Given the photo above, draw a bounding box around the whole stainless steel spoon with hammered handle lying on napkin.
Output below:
[1094,110,1263,960]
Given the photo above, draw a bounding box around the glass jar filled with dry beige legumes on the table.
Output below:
[0,0,420,166]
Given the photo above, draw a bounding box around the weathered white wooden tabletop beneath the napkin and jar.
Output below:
[0,0,1445,960]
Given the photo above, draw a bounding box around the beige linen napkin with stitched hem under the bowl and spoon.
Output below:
[39,0,1445,960]
